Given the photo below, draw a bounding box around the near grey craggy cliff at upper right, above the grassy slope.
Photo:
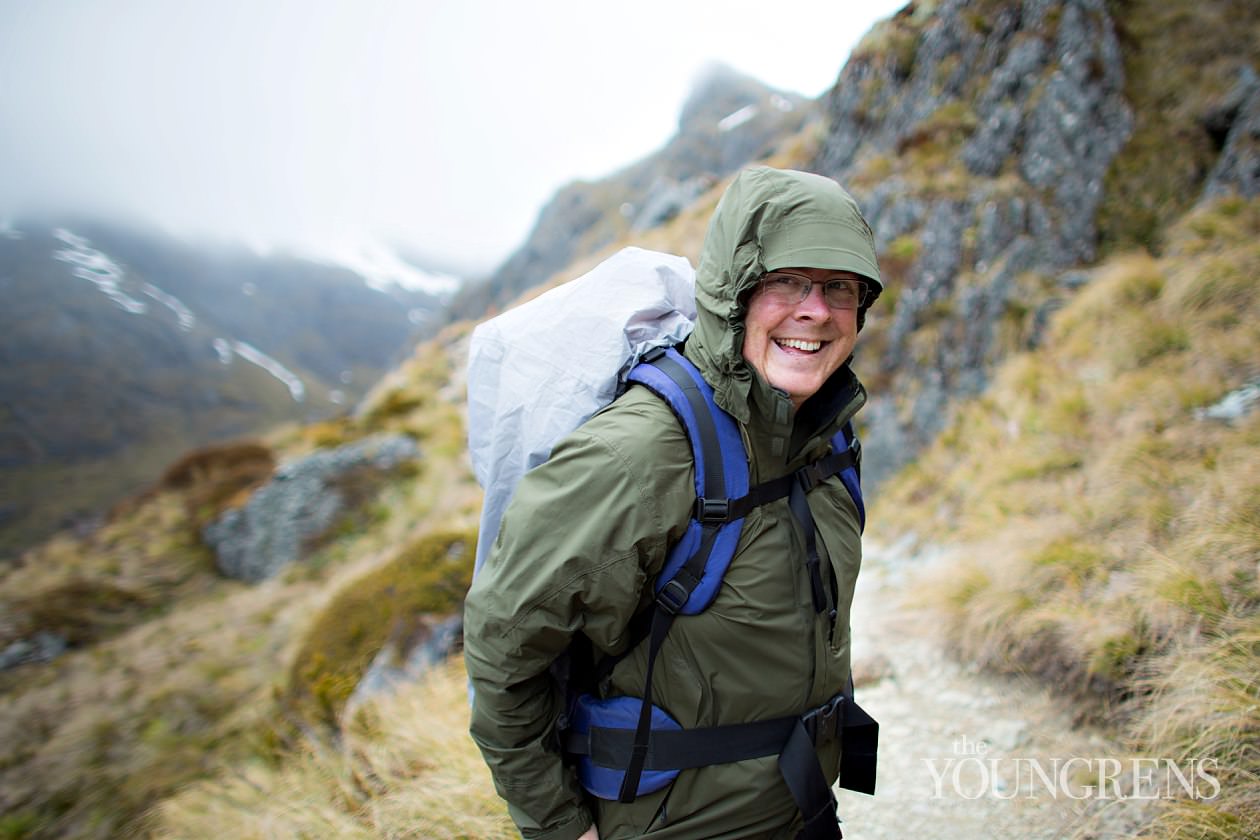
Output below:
[810,0,1260,485]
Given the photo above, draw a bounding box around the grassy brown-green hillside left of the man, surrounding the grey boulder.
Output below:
[0,332,480,837]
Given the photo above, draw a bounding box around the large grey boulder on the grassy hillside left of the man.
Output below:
[202,436,420,583]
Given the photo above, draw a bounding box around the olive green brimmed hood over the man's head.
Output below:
[687,166,883,433]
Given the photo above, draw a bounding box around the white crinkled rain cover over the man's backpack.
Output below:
[467,248,696,570]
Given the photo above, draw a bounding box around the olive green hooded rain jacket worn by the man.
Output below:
[465,169,878,840]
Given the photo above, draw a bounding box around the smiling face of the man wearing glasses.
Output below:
[743,268,861,408]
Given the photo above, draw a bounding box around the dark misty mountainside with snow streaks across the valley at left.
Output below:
[0,222,453,555]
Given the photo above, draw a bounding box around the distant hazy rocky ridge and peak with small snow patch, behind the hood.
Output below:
[450,65,818,320]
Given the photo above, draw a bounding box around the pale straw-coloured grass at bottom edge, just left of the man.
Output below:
[149,660,519,840]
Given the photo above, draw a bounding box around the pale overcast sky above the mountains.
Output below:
[0,0,903,270]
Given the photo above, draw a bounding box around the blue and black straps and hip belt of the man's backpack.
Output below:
[469,249,878,837]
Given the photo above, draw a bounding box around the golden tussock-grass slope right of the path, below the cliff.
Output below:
[876,199,1260,837]
